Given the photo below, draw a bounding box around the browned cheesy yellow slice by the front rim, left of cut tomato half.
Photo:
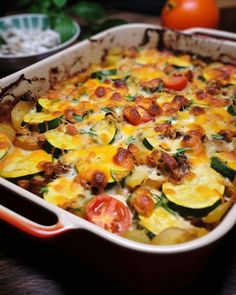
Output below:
[43,176,84,208]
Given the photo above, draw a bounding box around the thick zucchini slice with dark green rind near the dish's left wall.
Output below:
[22,112,62,133]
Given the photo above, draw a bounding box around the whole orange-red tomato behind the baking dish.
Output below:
[161,0,219,30]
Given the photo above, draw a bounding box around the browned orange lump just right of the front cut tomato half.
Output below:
[130,188,155,217]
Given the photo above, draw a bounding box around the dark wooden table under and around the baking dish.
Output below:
[0,7,236,295]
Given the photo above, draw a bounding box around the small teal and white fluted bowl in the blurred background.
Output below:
[0,13,80,73]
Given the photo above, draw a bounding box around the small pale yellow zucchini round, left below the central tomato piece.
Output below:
[91,120,116,144]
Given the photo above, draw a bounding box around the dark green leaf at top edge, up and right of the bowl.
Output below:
[71,1,106,22]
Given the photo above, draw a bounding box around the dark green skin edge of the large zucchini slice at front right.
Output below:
[168,200,221,217]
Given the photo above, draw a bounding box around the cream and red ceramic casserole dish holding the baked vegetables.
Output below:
[0,24,236,291]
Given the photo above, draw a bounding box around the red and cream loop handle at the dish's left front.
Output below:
[0,205,75,239]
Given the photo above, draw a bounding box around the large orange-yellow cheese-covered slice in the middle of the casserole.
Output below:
[64,145,130,183]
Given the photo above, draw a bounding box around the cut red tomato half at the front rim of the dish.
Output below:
[85,194,131,235]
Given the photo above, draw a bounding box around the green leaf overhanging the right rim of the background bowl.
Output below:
[50,15,76,43]
